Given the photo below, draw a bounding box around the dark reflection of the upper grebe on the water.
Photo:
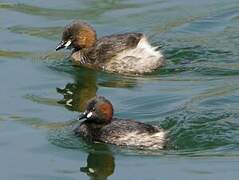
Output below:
[56,67,136,112]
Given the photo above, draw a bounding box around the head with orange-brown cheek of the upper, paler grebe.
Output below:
[56,21,96,51]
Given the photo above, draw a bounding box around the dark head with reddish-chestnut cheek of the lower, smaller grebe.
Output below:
[79,96,114,124]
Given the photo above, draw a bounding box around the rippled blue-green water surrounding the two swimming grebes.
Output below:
[0,0,239,180]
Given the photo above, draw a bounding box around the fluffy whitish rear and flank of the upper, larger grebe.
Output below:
[105,36,163,74]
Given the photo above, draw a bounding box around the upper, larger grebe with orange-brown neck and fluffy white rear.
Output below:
[56,22,164,74]
